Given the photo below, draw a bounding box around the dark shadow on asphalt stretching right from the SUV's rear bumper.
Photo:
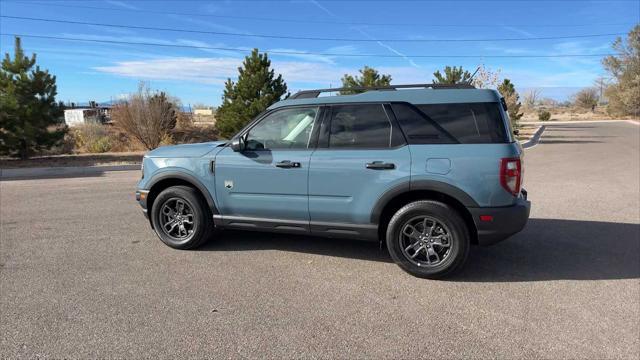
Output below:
[455,219,640,282]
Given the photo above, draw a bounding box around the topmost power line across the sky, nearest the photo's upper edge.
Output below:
[5,2,633,28]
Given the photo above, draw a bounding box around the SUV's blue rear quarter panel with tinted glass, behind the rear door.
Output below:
[391,102,518,206]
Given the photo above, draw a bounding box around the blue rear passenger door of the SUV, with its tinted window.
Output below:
[309,103,411,237]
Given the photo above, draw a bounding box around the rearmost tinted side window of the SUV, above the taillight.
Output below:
[417,103,508,144]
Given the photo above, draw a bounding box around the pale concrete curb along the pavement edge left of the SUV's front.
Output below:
[0,164,140,180]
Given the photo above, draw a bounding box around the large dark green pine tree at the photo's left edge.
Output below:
[0,37,65,159]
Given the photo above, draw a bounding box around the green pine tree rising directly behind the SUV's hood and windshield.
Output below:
[216,49,288,138]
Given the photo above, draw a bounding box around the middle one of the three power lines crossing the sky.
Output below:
[0,15,625,42]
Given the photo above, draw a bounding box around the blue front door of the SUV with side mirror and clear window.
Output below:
[215,107,320,231]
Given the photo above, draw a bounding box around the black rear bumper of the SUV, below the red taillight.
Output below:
[469,191,531,245]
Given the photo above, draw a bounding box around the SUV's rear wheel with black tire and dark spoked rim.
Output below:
[386,200,470,279]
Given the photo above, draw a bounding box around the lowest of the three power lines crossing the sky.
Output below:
[0,33,615,58]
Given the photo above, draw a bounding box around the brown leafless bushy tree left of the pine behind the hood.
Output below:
[112,83,178,150]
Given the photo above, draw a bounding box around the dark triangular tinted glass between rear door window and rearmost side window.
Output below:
[391,103,458,144]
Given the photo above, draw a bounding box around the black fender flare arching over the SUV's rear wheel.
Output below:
[371,180,480,224]
